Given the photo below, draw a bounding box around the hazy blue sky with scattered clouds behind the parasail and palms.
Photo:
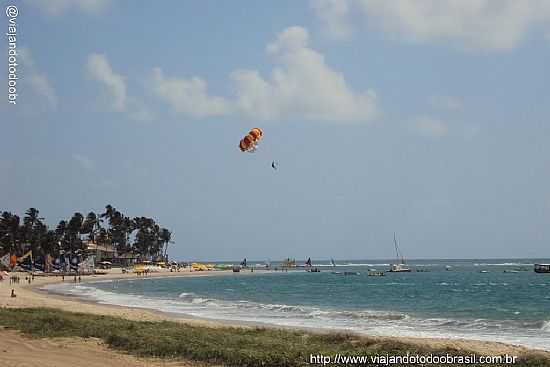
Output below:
[0,0,550,260]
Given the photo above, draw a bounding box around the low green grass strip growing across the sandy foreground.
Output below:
[0,308,550,367]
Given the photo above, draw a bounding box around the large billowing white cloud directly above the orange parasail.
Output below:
[232,27,376,121]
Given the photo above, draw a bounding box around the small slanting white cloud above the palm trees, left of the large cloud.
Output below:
[86,54,127,112]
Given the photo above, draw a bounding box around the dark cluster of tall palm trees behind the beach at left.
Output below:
[0,205,172,260]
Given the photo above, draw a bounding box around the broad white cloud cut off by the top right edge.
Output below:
[314,0,550,50]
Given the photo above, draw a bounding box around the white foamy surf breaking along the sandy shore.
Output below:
[45,283,550,349]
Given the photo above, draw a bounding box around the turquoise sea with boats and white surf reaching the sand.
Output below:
[47,259,550,350]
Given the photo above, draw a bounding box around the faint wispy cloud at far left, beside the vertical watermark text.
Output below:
[18,47,58,110]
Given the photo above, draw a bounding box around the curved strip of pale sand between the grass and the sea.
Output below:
[0,269,550,358]
